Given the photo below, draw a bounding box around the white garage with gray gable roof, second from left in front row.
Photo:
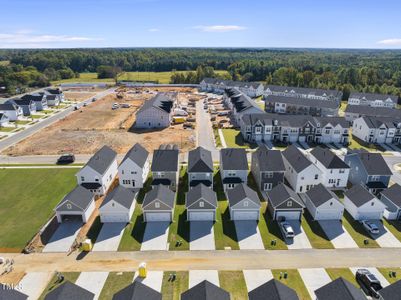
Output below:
[99,185,137,223]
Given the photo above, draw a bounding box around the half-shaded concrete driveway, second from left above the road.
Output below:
[93,223,127,251]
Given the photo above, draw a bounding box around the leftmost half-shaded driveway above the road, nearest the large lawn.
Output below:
[43,220,83,252]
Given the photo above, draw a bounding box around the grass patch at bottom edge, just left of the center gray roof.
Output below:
[161,271,189,300]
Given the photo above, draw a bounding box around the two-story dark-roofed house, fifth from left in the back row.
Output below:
[220,148,248,191]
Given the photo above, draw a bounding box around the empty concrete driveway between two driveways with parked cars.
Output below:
[318,220,358,248]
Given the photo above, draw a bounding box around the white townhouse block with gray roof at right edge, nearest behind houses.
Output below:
[352,116,401,144]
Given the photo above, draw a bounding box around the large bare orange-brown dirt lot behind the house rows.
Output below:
[3,89,199,156]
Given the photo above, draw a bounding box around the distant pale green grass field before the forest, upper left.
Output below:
[52,71,227,85]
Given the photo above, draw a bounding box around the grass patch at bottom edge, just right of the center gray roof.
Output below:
[219,271,248,300]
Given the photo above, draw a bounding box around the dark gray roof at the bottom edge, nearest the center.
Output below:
[181,280,230,300]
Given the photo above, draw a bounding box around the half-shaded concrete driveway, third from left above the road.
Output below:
[141,222,170,251]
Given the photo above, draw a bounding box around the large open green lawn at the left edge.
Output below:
[0,168,77,251]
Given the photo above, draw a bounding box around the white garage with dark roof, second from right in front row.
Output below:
[344,184,386,221]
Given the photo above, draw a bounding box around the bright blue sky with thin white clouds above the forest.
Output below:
[0,0,401,49]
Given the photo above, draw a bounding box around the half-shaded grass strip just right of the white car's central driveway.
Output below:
[301,210,334,249]
